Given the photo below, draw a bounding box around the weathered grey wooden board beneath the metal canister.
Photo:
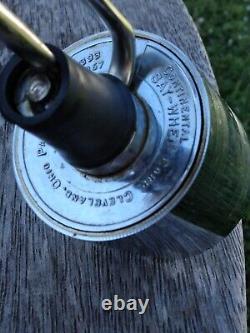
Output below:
[0,0,247,333]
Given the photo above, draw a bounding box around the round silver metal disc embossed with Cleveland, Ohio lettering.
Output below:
[13,32,208,241]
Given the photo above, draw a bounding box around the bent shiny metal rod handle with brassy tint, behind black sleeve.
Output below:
[0,0,135,85]
